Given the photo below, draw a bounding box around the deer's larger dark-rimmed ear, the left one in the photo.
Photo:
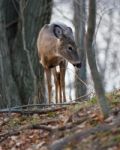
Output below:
[53,25,63,38]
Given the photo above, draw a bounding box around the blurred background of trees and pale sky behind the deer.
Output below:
[0,0,120,108]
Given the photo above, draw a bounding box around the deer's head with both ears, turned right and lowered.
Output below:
[53,24,81,68]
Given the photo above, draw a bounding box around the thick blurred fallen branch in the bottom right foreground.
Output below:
[49,119,120,150]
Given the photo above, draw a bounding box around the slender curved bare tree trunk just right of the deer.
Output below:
[86,0,110,117]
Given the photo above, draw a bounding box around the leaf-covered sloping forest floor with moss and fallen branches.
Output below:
[0,90,120,150]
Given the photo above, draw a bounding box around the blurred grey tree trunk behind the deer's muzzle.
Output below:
[74,0,87,101]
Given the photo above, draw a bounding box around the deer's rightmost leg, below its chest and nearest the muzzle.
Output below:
[60,61,67,102]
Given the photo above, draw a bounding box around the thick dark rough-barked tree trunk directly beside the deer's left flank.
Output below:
[12,0,52,104]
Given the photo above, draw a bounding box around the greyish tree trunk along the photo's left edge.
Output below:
[0,0,21,108]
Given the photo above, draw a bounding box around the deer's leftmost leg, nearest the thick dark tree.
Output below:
[45,69,52,104]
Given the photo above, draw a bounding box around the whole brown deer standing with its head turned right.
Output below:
[37,23,81,104]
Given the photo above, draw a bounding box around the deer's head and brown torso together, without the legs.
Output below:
[37,23,81,68]
